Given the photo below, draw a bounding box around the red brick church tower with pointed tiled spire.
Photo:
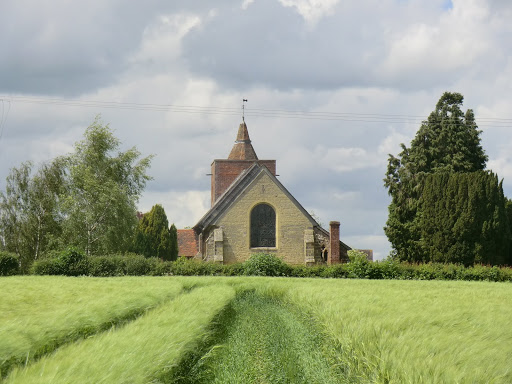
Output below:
[211,121,276,206]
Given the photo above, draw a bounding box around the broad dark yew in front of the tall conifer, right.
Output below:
[417,171,512,265]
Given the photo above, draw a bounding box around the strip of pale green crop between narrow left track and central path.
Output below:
[6,284,235,384]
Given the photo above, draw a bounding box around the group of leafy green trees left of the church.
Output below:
[0,118,183,273]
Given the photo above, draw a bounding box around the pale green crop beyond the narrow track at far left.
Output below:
[0,276,193,376]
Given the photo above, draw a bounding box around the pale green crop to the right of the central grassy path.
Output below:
[276,280,512,383]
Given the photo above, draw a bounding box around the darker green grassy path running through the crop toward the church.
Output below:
[166,292,343,384]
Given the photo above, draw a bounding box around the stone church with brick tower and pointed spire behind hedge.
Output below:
[178,120,351,265]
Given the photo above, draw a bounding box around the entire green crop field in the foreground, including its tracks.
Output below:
[0,276,512,384]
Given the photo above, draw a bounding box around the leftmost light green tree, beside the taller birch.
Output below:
[0,159,64,272]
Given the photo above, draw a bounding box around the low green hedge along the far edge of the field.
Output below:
[0,250,512,282]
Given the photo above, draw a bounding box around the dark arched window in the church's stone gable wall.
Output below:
[251,204,276,248]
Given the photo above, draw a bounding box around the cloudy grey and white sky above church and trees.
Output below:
[0,0,512,259]
